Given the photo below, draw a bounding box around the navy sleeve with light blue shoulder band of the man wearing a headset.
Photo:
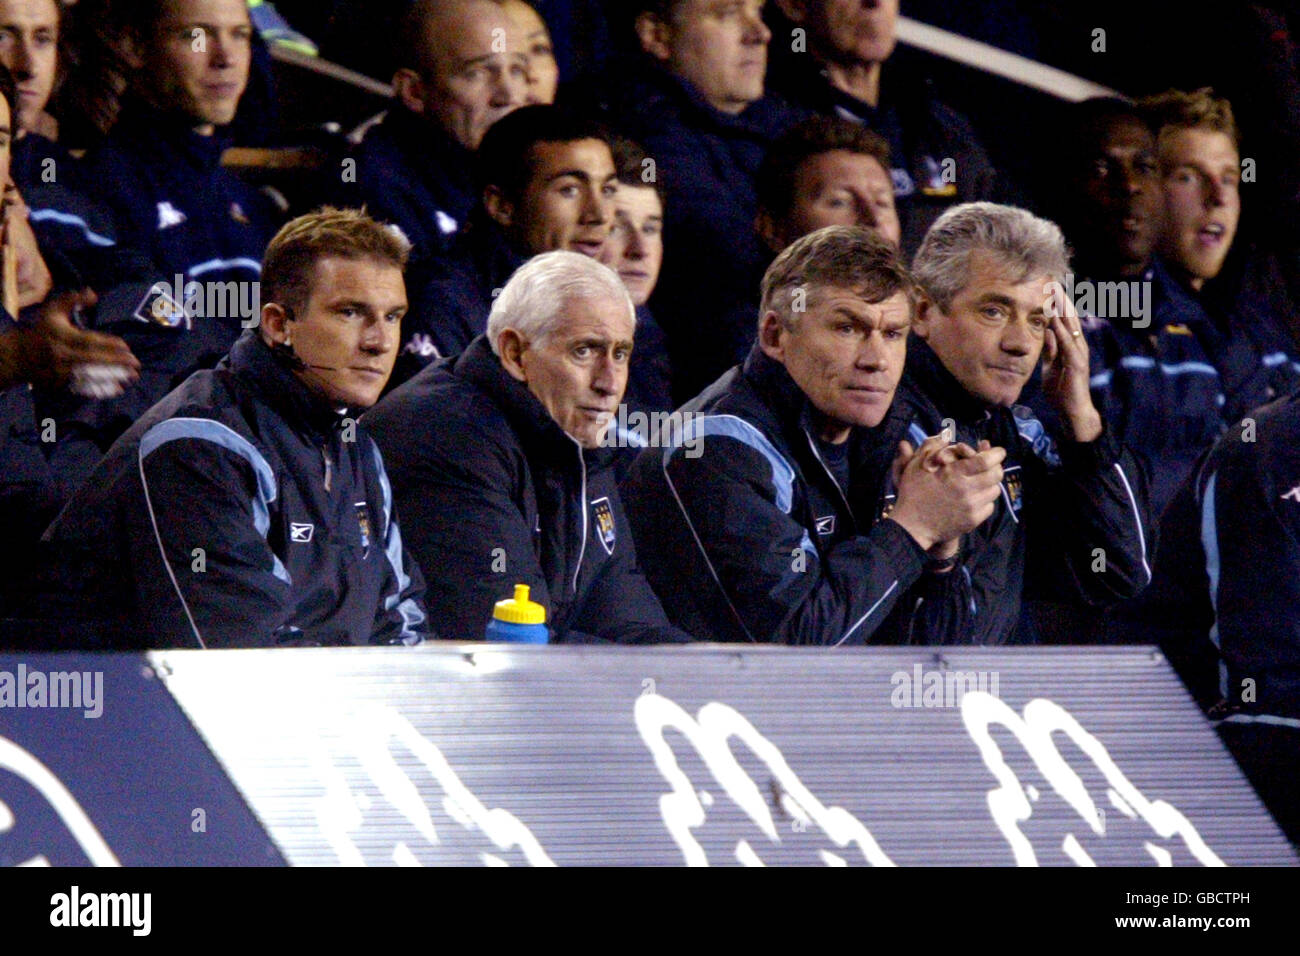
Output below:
[130,429,291,648]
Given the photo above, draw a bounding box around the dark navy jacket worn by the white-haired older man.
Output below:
[365,336,688,644]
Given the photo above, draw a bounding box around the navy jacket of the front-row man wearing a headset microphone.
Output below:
[39,330,429,649]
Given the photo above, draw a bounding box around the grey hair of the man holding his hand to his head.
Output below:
[911,203,1070,312]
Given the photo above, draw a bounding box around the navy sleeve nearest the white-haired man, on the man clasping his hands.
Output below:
[666,436,924,645]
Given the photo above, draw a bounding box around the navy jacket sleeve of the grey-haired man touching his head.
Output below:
[1023,427,1153,605]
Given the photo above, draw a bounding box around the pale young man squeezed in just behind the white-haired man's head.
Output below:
[601,137,673,412]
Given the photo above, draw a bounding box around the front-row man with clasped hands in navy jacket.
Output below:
[624,226,1004,645]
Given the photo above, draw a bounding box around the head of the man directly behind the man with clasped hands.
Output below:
[757,116,901,254]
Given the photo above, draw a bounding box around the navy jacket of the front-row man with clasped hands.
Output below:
[623,347,956,645]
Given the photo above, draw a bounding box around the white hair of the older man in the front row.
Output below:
[488,251,637,355]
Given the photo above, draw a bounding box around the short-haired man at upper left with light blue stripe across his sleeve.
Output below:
[69,0,278,421]
